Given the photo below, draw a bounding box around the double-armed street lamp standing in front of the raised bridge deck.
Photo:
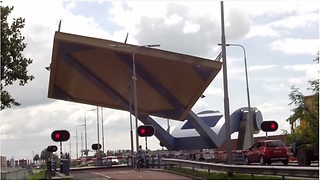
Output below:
[109,44,160,152]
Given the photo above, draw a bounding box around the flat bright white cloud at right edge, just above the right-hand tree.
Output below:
[267,38,319,55]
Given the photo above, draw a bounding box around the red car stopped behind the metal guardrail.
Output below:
[244,140,289,165]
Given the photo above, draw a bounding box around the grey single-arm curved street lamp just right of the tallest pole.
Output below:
[218,44,253,145]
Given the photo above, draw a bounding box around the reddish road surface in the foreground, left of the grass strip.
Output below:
[71,168,191,180]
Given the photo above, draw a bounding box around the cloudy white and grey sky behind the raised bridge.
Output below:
[0,0,319,159]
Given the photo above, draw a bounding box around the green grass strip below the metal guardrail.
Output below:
[165,167,298,179]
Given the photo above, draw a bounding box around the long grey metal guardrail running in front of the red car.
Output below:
[162,158,319,178]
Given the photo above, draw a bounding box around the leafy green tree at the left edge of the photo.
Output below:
[0,6,34,110]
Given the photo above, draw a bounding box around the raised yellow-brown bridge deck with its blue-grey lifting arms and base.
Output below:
[48,32,263,151]
